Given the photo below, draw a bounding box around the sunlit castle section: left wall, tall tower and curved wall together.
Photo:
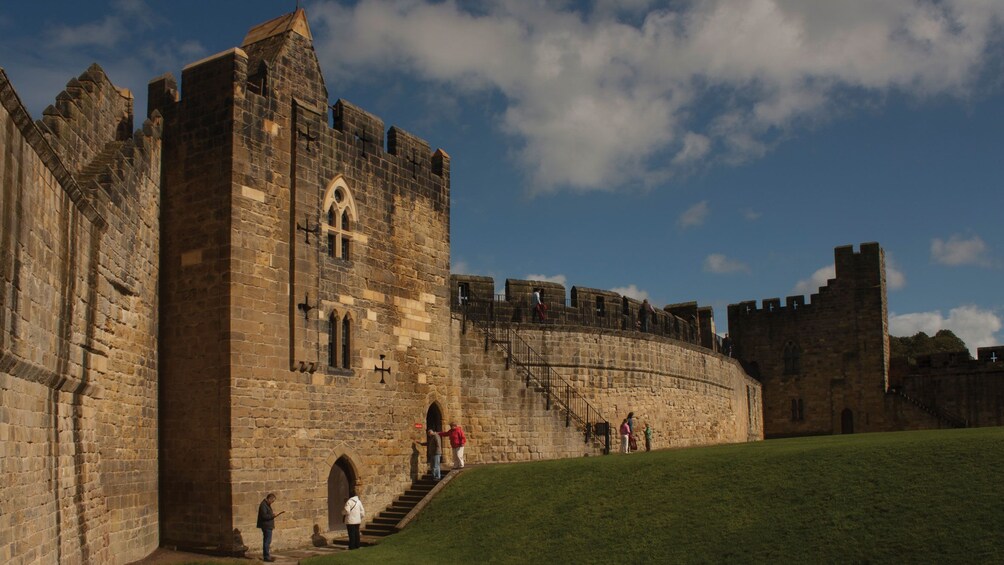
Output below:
[0,10,763,564]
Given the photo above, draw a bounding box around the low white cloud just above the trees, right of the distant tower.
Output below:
[889,305,1002,356]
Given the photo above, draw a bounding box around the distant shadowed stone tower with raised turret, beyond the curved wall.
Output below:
[729,243,897,438]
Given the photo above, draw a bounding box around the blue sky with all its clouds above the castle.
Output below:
[0,0,1004,350]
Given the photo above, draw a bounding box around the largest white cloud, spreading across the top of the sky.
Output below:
[311,0,1004,191]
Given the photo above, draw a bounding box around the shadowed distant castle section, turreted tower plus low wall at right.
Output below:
[729,243,1004,438]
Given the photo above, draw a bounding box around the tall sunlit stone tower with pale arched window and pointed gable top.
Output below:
[150,10,451,550]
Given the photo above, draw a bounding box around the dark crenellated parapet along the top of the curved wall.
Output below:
[450,275,718,350]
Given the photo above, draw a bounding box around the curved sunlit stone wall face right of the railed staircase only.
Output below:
[524,328,763,448]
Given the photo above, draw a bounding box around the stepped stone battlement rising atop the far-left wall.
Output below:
[36,63,133,175]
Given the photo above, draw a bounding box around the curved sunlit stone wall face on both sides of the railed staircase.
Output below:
[454,321,763,463]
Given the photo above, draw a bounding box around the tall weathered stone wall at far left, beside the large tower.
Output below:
[0,66,161,563]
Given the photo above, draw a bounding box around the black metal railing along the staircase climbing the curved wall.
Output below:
[460,296,610,454]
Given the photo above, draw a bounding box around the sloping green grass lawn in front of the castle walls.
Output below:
[308,428,1004,565]
